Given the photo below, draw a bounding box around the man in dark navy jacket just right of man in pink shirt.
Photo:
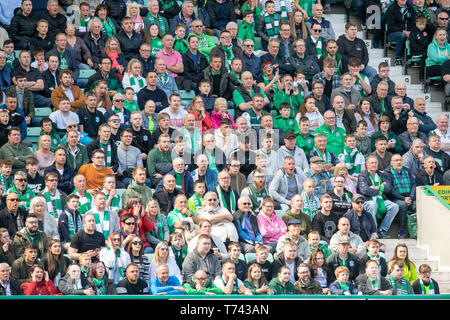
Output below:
[182,36,208,89]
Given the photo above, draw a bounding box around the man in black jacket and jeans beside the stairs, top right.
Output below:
[386,0,415,66]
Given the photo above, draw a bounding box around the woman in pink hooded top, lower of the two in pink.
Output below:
[256,198,287,252]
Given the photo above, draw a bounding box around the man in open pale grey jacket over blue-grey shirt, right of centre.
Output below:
[269,156,306,211]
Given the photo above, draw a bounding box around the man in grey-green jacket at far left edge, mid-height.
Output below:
[0,127,33,173]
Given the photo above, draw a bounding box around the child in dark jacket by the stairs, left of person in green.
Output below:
[408,15,432,80]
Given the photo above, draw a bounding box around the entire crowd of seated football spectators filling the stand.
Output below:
[0,0,450,295]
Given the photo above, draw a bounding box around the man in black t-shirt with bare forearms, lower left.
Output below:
[68,213,106,262]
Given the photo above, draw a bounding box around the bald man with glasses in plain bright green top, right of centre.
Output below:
[314,110,345,155]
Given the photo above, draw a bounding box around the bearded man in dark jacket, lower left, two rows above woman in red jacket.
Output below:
[12,213,48,260]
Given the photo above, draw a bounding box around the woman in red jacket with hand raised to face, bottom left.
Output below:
[20,264,61,296]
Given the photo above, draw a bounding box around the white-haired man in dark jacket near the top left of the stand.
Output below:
[83,17,108,68]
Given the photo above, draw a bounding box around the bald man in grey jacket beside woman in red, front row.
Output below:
[58,263,95,296]
